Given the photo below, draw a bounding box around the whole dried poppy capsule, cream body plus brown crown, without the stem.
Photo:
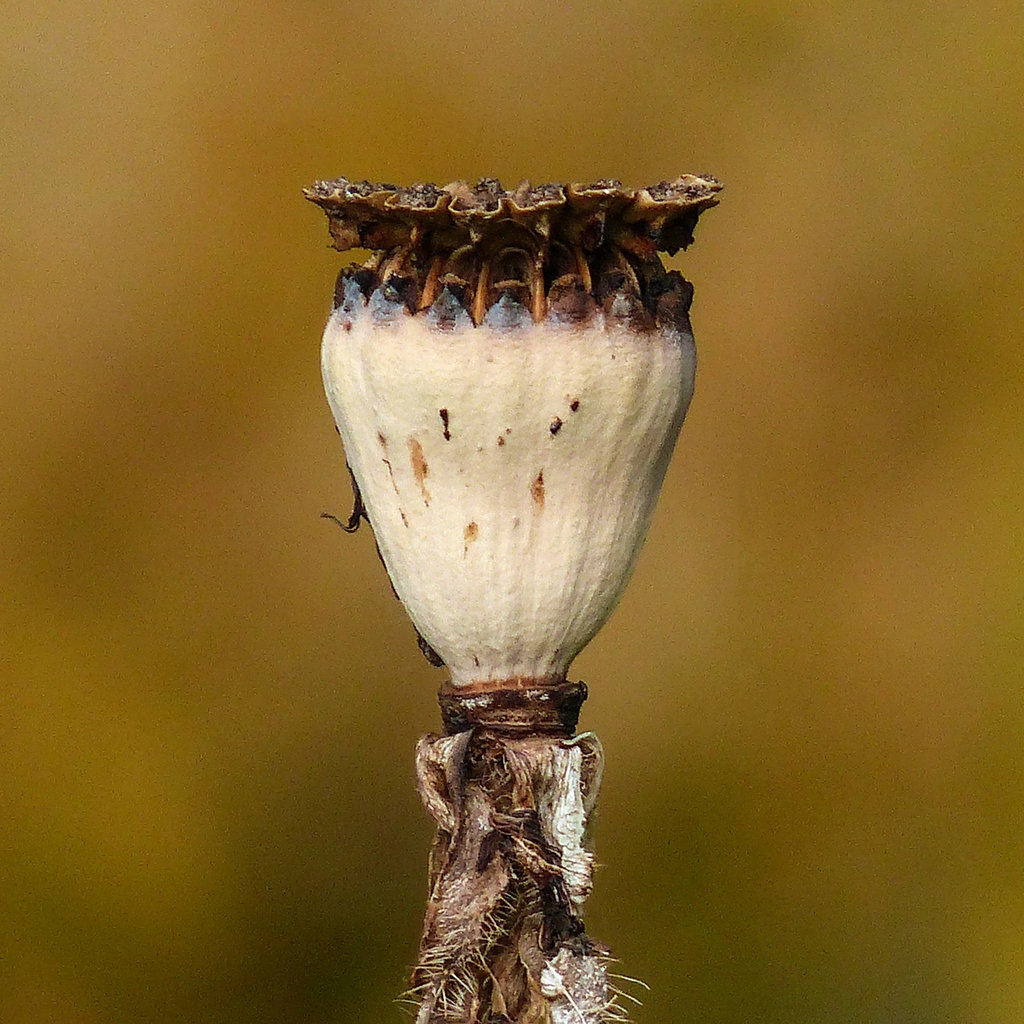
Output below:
[306,177,720,687]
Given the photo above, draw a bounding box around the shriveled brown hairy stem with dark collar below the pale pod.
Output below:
[410,680,624,1024]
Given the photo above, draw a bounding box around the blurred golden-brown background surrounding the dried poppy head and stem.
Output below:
[0,0,1024,1024]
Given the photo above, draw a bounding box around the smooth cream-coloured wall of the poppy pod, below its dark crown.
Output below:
[323,299,694,685]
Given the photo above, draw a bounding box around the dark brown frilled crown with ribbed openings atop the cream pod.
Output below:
[305,174,721,330]
